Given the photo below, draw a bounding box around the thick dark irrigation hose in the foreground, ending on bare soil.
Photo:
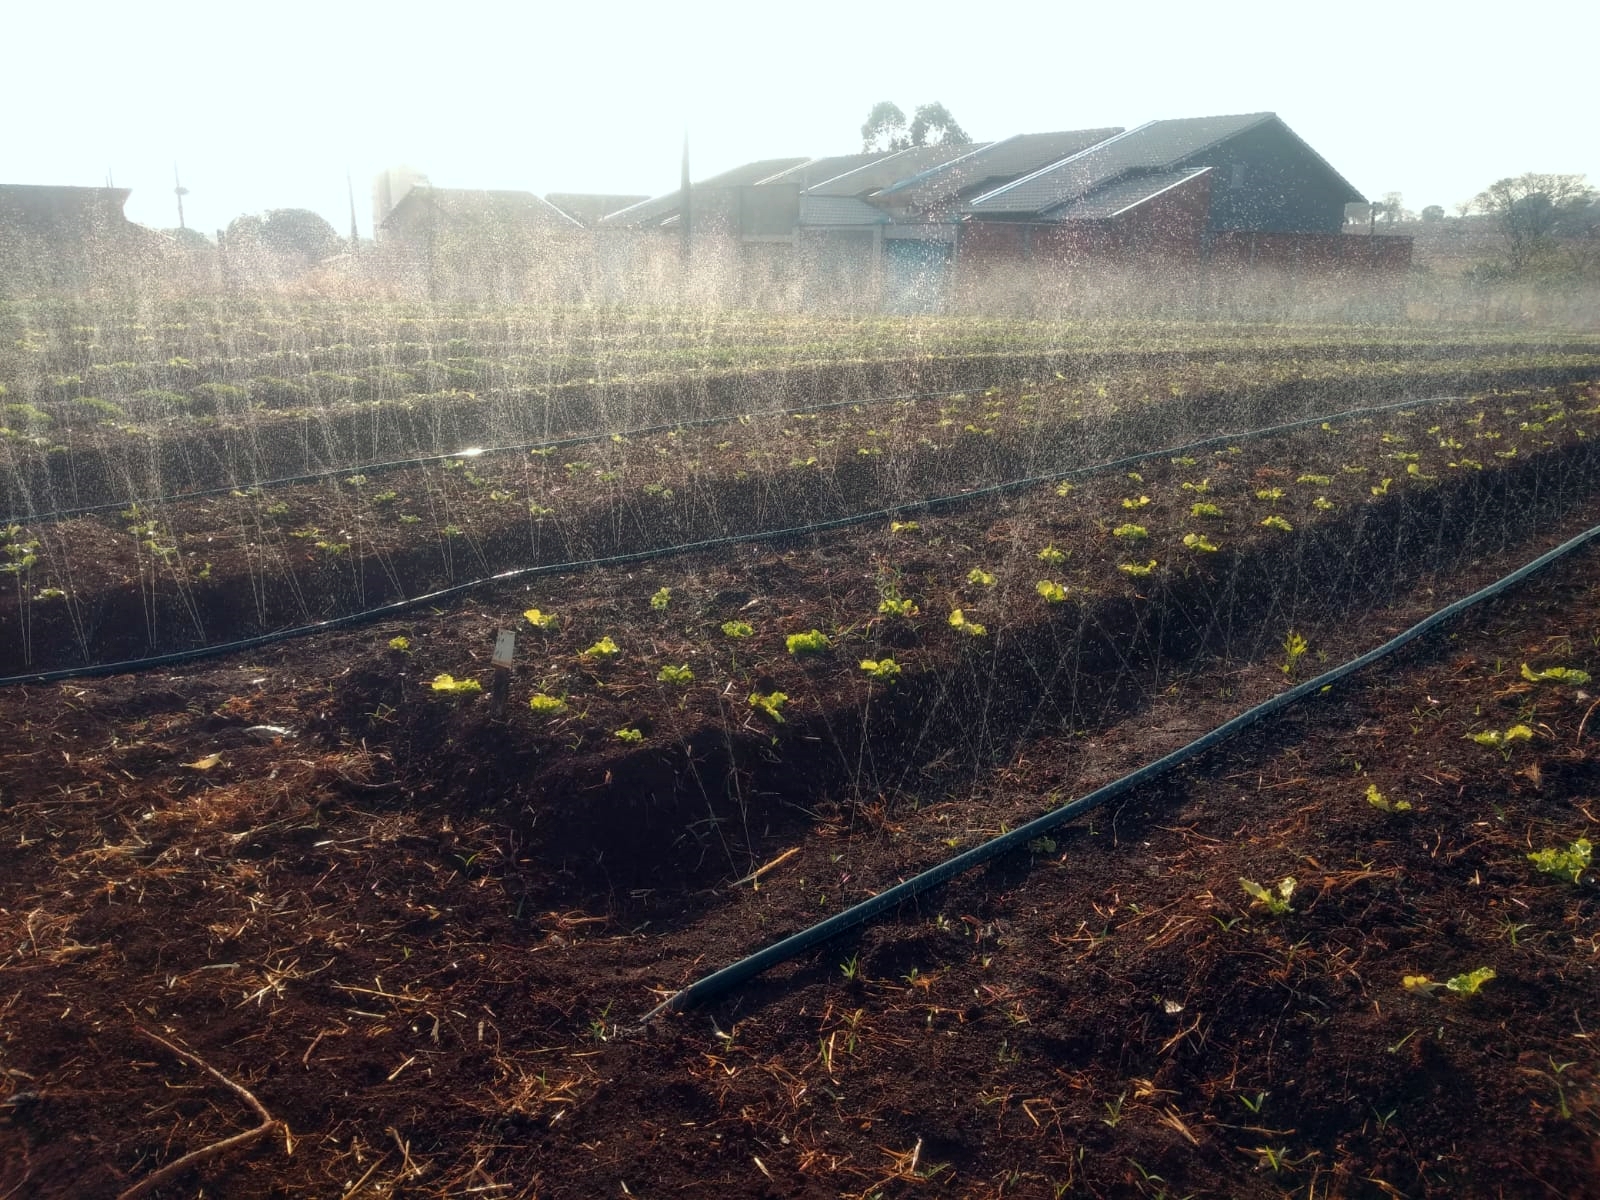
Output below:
[640,525,1600,1026]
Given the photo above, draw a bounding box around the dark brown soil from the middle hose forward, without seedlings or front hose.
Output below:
[0,382,1600,1200]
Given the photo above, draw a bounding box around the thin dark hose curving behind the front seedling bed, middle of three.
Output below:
[0,395,1469,688]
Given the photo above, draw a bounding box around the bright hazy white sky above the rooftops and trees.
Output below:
[0,0,1600,235]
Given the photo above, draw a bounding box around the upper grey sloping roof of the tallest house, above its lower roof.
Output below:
[966,112,1277,213]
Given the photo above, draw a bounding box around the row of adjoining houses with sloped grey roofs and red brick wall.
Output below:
[598,112,1410,309]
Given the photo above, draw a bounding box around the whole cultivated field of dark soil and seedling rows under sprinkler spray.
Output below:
[0,296,1600,1200]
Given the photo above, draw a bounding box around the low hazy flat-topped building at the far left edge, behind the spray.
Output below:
[0,184,176,288]
